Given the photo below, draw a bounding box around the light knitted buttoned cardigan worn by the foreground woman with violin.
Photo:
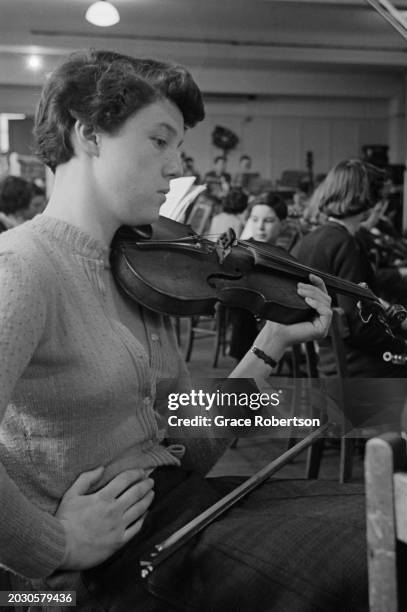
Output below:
[0,215,207,578]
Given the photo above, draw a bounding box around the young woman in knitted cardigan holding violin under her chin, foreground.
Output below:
[0,51,367,612]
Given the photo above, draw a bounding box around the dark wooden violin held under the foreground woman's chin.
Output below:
[111,216,406,333]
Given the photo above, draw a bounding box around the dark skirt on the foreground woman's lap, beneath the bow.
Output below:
[82,468,368,612]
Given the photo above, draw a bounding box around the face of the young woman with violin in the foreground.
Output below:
[93,99,184,225]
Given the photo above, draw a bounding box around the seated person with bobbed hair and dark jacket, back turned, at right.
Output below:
[294,159,407,378]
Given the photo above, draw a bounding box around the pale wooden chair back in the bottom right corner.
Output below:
[365,433,407,612]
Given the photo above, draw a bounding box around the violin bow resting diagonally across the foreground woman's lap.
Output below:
[140,423,332,578]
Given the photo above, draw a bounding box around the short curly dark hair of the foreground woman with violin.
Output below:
[34,49,205,172]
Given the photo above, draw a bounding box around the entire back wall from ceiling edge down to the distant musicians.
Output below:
[0,67,398,180]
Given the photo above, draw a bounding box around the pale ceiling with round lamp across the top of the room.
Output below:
[0,0,407,70]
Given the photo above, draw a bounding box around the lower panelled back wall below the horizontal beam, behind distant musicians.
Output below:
[184,99,389,180]
